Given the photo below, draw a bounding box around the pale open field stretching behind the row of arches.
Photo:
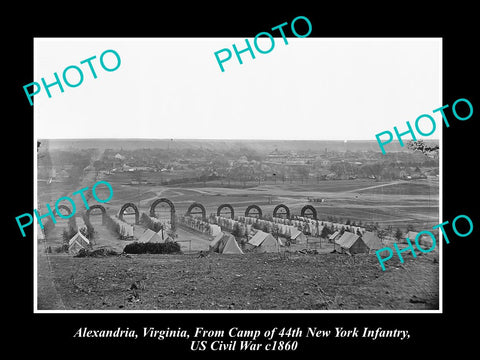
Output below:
[38,173,439,231]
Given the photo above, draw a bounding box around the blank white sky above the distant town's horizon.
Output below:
[33,38,443,140]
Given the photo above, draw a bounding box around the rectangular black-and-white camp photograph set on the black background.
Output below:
[33,38,443,312]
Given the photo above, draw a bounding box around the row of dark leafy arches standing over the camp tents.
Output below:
[58,198,317,229]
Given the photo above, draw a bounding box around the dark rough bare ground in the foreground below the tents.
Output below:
[40,249,438,310]
